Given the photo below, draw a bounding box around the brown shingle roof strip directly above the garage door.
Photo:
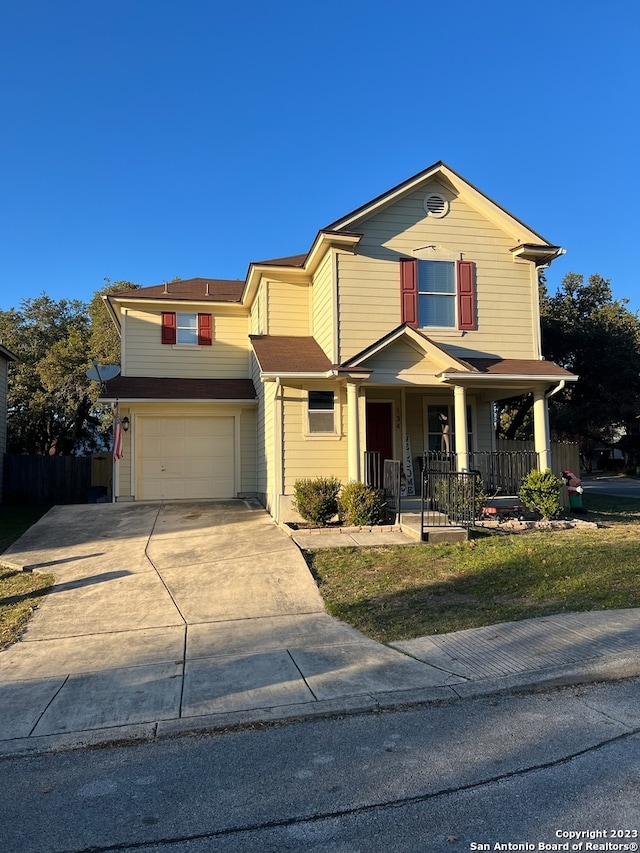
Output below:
[100,376,256,400]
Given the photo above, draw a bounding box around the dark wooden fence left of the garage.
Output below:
[3,453,111,504]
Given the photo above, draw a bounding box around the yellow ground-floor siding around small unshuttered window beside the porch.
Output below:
[283,383,348,495]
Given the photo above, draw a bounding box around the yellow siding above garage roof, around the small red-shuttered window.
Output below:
[122,305,249,379]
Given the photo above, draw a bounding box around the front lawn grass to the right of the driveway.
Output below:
[306,494,640,642]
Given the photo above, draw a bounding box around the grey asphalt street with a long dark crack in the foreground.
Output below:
[0,679,640,853]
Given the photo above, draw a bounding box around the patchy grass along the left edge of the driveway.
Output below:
[0,505,54,649]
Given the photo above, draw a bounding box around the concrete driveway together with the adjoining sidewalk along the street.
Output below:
[0,501,640,755]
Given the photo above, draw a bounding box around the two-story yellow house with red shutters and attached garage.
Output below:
[103,162,576,519]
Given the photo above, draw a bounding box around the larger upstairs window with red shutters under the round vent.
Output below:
[400,258,477,331]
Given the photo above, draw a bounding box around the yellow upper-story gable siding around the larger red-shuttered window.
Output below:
[338,184,538,360]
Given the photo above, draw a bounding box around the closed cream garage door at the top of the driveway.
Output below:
[136,417,235,500]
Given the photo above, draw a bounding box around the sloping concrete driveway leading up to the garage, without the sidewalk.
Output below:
[0,501,464,746]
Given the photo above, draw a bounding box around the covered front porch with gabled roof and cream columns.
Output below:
[340,325,577,496]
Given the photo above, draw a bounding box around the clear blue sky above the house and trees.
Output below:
[0,0,640,310]
